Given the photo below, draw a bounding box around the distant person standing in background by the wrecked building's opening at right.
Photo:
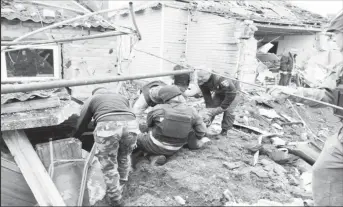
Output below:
[279,49,297,86]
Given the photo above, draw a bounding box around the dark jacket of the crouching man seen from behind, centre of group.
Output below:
[147,103,207,147]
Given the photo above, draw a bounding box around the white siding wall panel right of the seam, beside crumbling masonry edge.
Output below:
[186,12,239,76]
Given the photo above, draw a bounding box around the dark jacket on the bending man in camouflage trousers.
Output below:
[74,93,136,138]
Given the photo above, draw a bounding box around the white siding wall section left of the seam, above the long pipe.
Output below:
[115,9,162,78]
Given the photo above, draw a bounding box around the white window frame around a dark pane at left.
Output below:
[1,45,62,83]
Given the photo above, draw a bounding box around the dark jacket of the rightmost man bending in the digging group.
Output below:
[199,74,238,109]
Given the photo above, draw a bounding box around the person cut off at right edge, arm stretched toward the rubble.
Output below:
[269,11,343,206]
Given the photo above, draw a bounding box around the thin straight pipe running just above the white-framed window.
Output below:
[1,31,131,46]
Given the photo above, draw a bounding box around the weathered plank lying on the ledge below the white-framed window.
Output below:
[1,96,61,114]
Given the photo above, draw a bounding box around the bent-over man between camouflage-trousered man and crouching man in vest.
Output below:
[133,81,167,116]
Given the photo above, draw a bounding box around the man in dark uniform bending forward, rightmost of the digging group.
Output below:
[198,70,239,139]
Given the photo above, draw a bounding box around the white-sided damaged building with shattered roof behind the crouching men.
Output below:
[112,1,340,87]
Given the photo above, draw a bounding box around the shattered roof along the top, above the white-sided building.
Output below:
[112,0,329,28]
